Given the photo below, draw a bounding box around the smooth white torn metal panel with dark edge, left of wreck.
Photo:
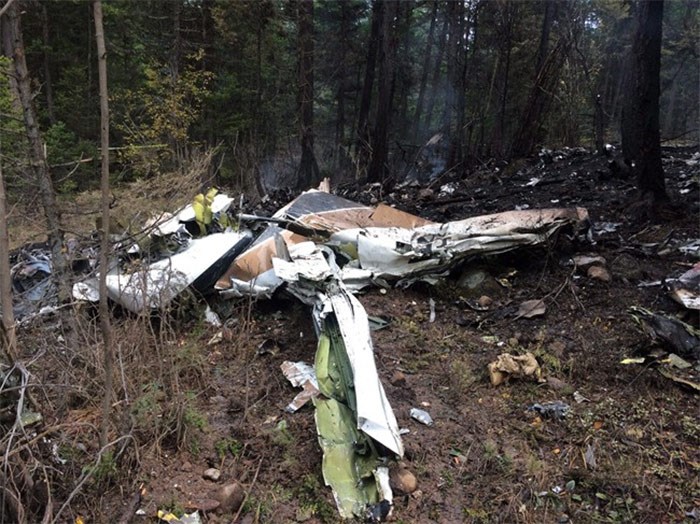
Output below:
[73,232,251,313]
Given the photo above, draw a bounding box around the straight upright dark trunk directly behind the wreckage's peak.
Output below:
[297,0,320,189]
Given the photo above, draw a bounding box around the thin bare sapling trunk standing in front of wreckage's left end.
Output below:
[92,0,114,448]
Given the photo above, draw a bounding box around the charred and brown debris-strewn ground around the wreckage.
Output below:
[6,148,700,523]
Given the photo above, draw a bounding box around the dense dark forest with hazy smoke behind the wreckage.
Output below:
[0,0,700,198]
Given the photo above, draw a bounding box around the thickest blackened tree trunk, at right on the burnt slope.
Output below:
[622,0,668,201]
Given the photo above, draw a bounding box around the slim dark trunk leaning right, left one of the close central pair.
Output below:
[357,0,384,178]
